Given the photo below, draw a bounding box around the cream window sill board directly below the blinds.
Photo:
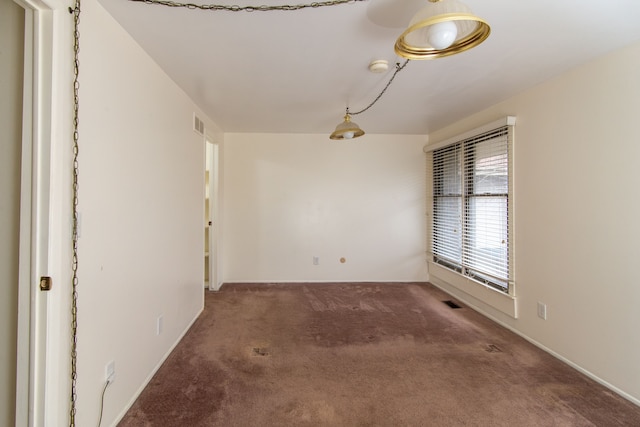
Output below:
[427,262,518,319]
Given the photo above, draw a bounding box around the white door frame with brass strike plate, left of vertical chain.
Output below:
[14,0,54,426]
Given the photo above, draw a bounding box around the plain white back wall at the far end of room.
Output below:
[222,134,426,282]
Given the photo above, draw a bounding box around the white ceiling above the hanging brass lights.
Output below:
[100,0,640,135]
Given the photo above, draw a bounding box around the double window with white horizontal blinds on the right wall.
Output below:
[431,126,512,293]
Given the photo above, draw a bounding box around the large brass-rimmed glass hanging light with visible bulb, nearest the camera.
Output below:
[395,0,491,59]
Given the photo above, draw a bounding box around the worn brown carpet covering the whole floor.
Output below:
[119,283,640,427]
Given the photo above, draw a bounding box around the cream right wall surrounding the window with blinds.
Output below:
[429,40,640,404]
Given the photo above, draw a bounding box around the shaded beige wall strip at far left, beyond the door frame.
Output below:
[0,0,24,426]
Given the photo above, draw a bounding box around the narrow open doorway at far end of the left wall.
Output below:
[204,136,220,291]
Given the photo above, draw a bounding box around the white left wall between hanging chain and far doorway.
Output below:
[76,0,219,426]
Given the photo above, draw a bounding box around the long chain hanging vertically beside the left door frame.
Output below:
[69,0,80,427]
